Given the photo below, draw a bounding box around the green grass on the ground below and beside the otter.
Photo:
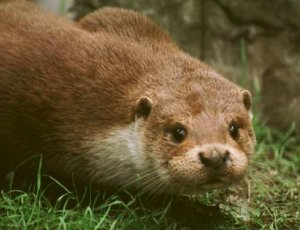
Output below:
[0,114,300,230]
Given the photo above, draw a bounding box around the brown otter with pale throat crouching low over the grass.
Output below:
[0,1,255,194]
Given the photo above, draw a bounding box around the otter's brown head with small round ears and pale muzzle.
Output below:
[135,74,255,194]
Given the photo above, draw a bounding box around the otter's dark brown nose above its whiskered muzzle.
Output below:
[199,149,230,169]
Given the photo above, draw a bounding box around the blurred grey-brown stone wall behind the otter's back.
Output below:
[36,0,300,136]
